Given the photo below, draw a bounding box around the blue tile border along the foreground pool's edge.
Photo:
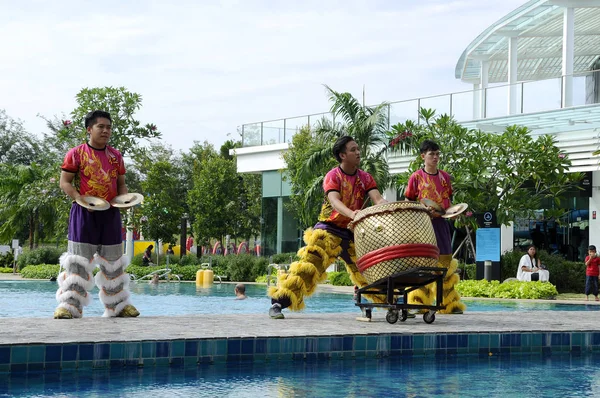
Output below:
[5,332,600,373]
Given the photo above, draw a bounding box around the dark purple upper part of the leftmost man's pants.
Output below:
[69,203,123,246]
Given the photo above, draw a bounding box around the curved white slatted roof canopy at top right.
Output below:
[455,0,600,83]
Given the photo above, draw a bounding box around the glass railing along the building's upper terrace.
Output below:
[238,70,600,147]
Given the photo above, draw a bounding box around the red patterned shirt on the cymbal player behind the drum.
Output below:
[404,169,452,209]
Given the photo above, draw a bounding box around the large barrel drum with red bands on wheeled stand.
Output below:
[348,201,440,284]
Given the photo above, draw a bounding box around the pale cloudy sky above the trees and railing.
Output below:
[0,0,526,151]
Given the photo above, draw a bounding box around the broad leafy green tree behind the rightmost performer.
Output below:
[388,109,581,225]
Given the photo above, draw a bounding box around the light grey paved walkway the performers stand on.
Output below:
[0,311,600,345]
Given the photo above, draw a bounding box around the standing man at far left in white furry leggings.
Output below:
[54,110,140,319]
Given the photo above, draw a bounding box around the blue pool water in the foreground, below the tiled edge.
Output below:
[0,354,600,398]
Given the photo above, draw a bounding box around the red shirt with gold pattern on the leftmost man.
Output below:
[61,143,125,202]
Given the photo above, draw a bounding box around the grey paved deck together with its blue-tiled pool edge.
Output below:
[0,309,600,373]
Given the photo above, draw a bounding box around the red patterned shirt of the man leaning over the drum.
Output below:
[319,166,377,228]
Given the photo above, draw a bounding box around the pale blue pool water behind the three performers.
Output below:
[0,281,600,318]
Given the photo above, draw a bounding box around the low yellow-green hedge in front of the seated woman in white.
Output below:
[456,280,558,299]
